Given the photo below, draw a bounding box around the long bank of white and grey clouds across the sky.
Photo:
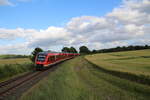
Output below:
[0,0,150,53]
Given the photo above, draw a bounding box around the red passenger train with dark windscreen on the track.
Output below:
[35,51,80,69]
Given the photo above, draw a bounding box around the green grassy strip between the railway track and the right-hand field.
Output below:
[20,57,150,100]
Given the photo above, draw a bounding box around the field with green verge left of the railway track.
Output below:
[0,55,33,81]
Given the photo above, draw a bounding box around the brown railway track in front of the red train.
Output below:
[0,66,56,100]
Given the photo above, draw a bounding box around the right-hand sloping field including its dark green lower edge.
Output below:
[85,50,150,85]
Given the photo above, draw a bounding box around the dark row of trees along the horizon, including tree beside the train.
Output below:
[30,45,150,62]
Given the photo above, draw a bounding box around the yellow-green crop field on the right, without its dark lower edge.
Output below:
[85,50,150,75]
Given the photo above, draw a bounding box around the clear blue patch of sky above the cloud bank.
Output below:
[0,0,121,29]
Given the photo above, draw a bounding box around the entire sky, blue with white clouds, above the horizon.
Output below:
[0,0,150,54]
